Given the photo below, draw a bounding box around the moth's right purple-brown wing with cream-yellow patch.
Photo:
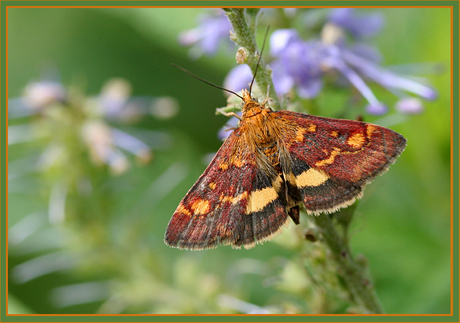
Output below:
[275,111,406,214]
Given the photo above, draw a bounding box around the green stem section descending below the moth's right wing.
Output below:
[313,214,383,314]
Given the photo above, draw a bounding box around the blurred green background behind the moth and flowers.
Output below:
[8,8,451,314]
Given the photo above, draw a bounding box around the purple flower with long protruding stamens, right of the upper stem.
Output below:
[270,19,437,115]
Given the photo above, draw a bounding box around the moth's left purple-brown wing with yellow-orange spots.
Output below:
[165,129,287,249]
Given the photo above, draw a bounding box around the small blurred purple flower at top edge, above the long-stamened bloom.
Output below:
[328,8,384,39]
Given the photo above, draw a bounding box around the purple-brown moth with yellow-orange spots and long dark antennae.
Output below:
[164,29,406,250]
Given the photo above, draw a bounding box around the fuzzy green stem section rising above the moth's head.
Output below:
[224,8,280,110]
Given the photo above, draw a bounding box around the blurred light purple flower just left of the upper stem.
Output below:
[179,9,234,56]
